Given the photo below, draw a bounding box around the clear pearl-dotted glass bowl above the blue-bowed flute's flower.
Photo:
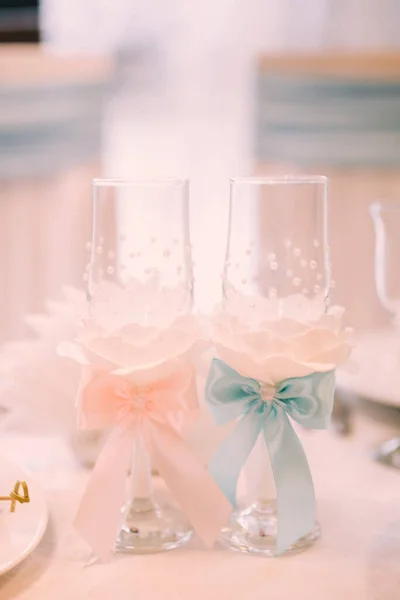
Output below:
[222,176,331,318]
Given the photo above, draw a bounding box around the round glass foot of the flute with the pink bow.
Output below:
[115,498,193,554]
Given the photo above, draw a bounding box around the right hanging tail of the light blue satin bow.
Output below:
[264,409,315,555]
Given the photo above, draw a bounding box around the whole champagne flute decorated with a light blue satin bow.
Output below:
[206,176,334,556]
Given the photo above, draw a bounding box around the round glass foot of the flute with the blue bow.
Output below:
[219,501,321,556]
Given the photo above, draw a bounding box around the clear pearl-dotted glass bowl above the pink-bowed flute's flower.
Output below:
[86,179,193,326]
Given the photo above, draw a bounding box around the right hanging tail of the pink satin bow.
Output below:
[143,420,232,548]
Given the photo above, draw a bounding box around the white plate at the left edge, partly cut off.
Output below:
[0,456,48,575]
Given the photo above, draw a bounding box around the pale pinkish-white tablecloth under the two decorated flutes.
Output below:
[0,416,400,600]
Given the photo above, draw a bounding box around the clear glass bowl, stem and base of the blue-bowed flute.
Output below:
[221,176,330,556]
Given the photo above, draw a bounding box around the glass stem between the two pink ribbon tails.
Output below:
[129,421,152,504]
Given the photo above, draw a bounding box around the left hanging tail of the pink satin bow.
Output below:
[74,427,133,562]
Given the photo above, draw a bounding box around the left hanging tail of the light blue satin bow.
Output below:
[208,412,263,506]
